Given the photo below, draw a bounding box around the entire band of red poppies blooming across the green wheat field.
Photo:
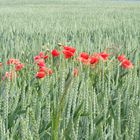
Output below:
[0,45,133,79]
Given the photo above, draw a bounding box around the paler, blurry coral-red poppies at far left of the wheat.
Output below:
[1,58,24,80]
